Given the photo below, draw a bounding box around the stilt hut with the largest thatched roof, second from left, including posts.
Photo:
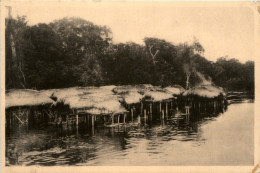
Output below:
[50,86,128,126]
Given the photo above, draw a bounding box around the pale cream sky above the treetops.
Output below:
[6,2,256,62]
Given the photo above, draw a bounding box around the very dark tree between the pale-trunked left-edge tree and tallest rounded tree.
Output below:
[24,24,67,89]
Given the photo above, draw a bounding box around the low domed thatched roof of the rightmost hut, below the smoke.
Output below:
[183,84,225,98]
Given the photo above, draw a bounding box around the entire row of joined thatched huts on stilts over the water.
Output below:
[5,84,225,127]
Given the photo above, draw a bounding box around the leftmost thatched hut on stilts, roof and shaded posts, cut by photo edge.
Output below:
[5,89,54,127]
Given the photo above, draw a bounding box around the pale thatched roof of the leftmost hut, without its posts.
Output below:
[5,89,54,108]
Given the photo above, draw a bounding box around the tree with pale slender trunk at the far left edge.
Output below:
[5,15,28,89]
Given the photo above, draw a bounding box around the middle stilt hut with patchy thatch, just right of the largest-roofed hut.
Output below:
[113,84,179,120]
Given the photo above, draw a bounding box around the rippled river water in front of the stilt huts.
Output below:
[6,102,254,166]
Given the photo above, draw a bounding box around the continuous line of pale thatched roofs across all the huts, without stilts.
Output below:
[6,84,225,113]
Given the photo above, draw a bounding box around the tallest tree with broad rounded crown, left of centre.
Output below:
[50,18,112,85]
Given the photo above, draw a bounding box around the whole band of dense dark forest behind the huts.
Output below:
[5,16,254,94]
